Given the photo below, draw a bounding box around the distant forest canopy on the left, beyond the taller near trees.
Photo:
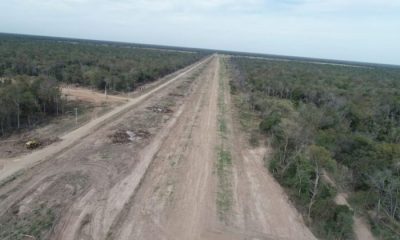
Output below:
[0,35,202,91]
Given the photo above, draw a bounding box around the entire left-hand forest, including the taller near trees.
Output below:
[0,34,203,135]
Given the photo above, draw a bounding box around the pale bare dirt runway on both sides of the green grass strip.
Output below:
[105,56,315,240]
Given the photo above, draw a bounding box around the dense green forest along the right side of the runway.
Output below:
[231,57,400,239]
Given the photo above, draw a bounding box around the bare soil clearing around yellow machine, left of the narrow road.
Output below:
[0,86,129,160]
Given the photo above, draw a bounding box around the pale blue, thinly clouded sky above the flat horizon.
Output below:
[0,0,400,65]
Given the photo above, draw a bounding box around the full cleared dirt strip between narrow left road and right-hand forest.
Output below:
[0,56,314,240]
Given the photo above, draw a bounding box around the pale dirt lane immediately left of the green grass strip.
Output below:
[109,53,218,239]
